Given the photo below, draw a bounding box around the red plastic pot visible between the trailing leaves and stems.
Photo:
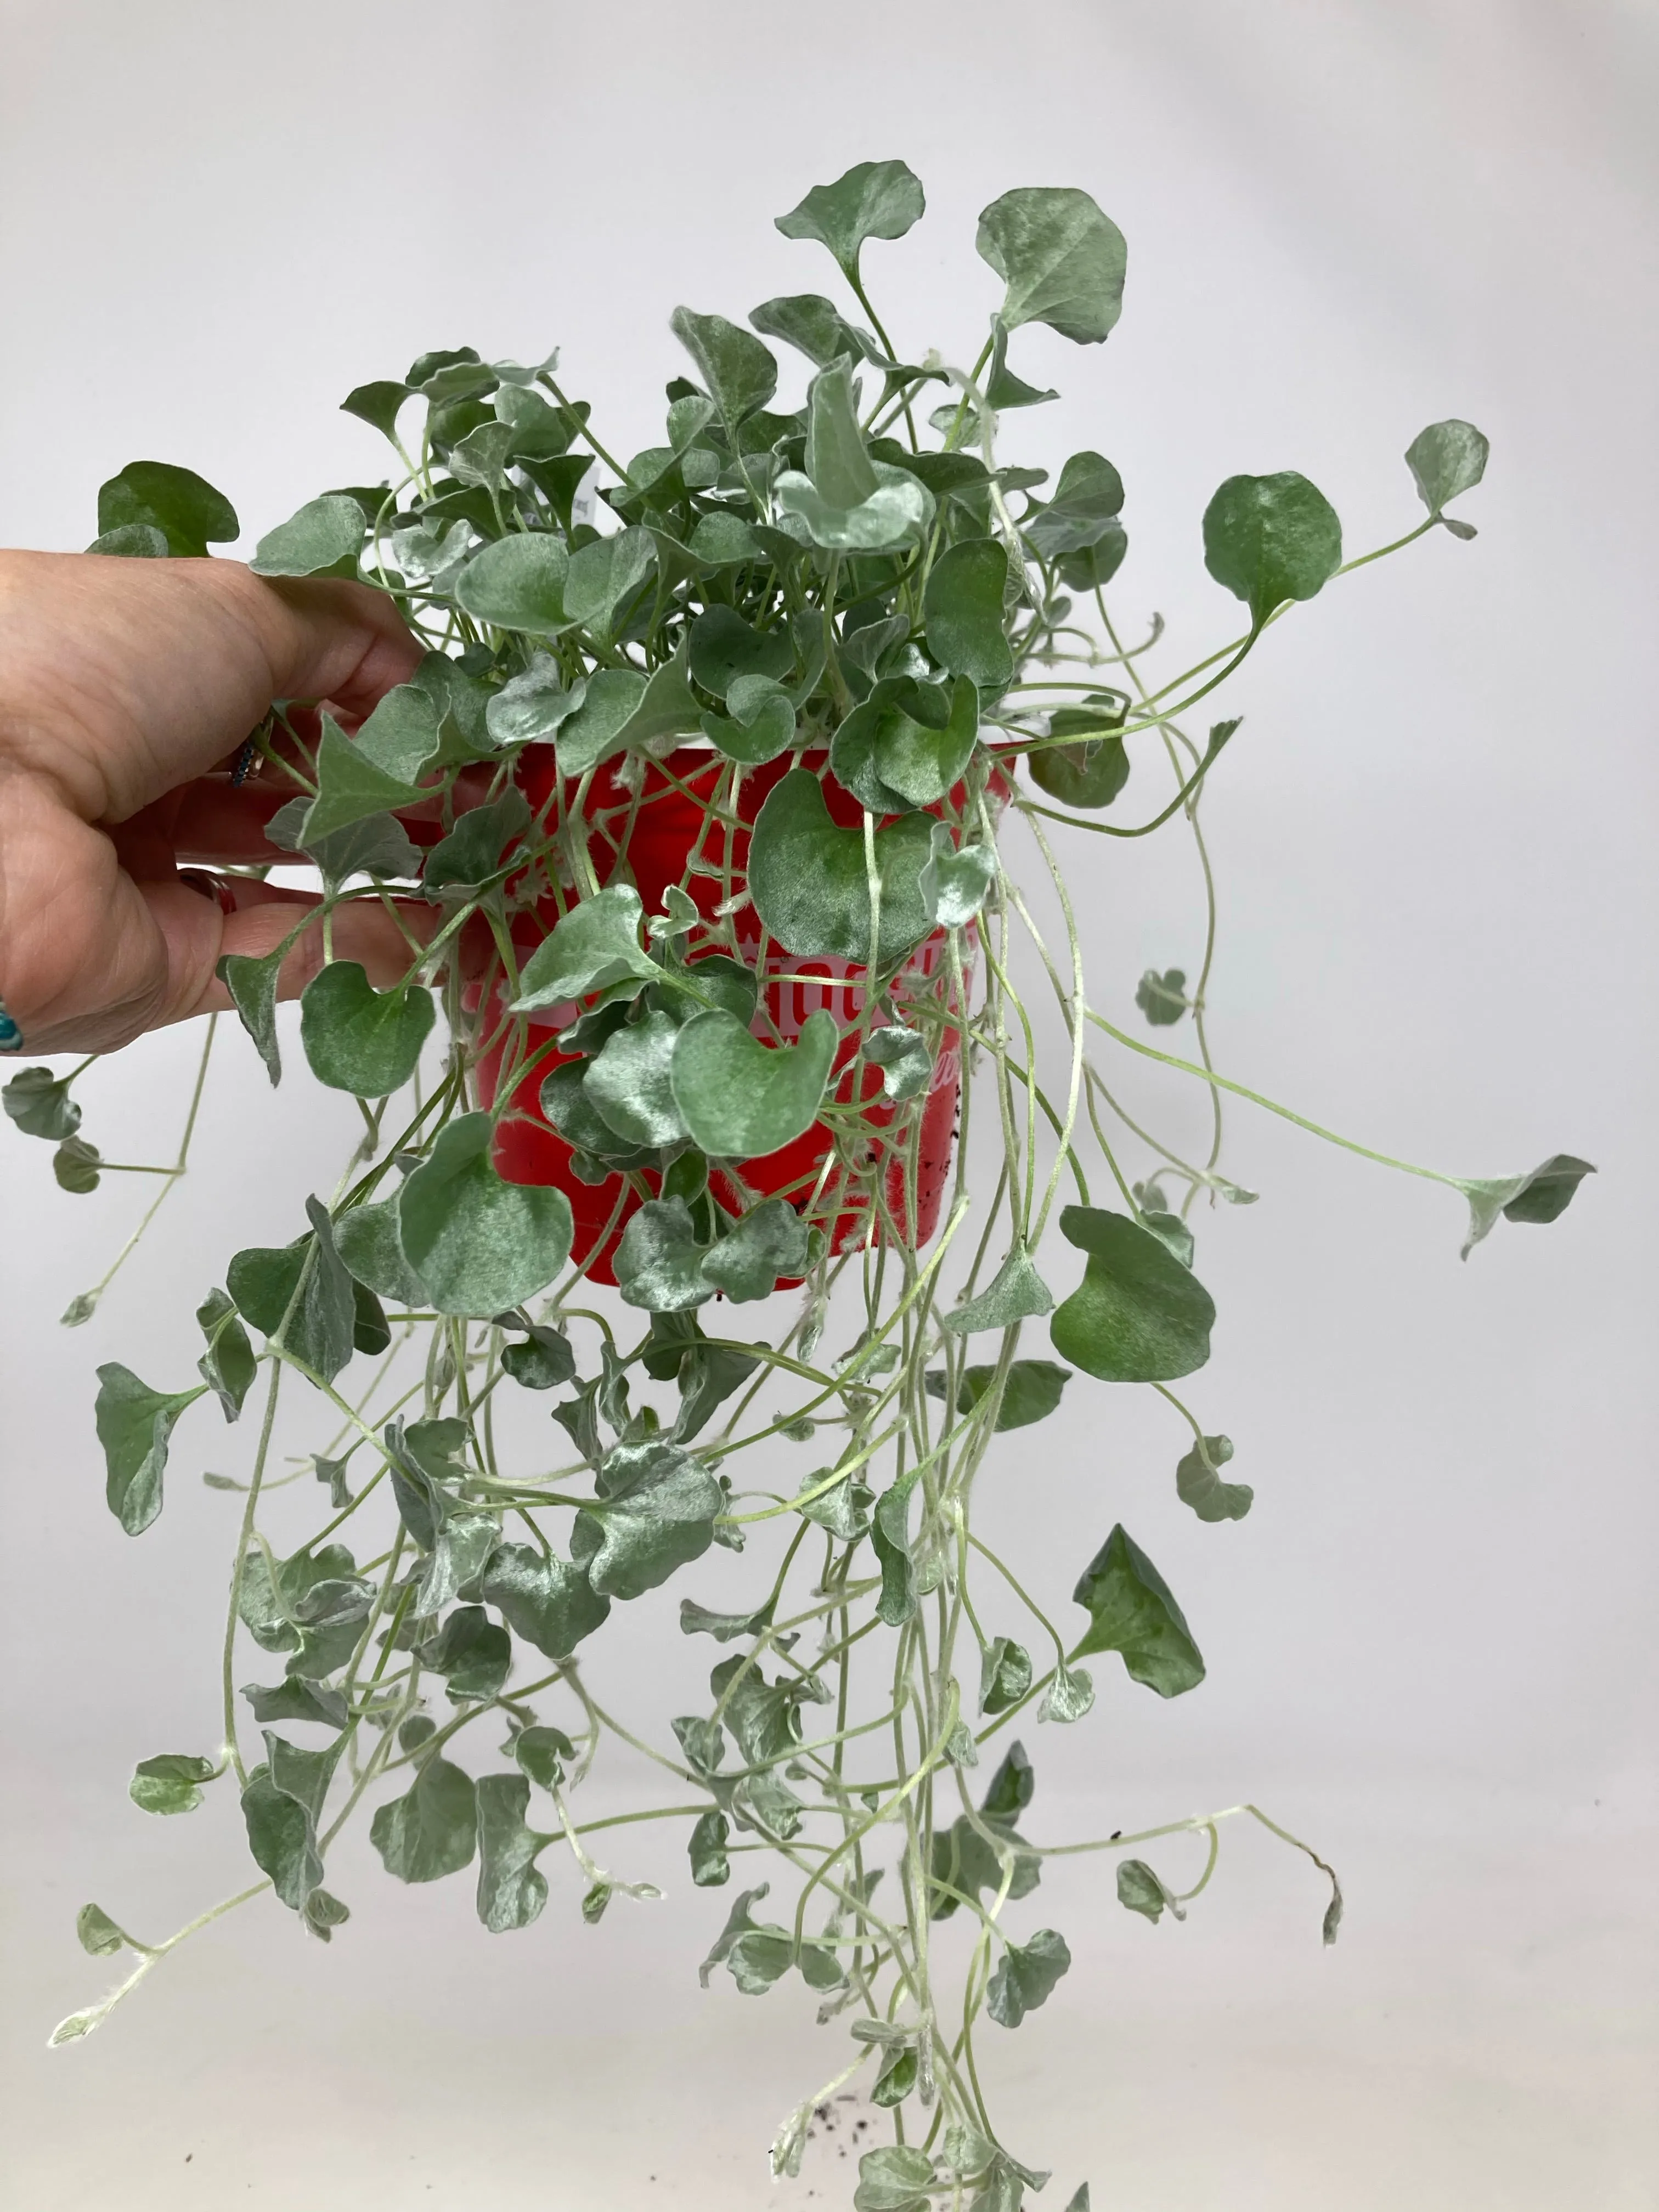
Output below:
[478,746,1007,1283]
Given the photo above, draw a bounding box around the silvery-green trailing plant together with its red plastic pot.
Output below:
[4,161,1588,2212]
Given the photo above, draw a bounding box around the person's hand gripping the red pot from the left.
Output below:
[0,553,420,1053]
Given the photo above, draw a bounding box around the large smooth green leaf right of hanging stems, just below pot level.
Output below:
[1048,1205,1215,1383]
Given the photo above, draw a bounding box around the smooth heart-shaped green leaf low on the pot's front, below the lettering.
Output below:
[670,1013,840,1159]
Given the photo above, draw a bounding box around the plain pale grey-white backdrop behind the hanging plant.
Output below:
[0,0,1659,2212]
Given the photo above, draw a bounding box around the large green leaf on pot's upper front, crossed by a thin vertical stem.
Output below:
[750,768,934,969]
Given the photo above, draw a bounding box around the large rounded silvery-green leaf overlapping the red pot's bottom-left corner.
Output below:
[398,1113,573,1314]
